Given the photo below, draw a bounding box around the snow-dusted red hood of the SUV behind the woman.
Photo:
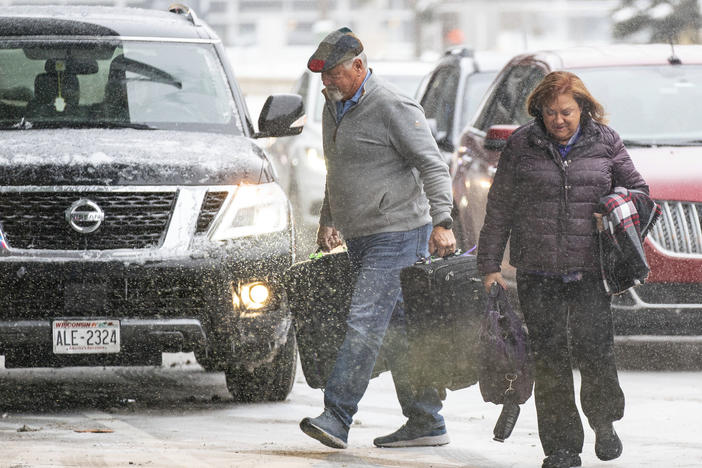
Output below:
[627,146,702,202]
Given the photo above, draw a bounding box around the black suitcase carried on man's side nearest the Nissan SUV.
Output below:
[283,251,387,388]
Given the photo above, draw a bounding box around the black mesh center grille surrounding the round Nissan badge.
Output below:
[0,191,176,250]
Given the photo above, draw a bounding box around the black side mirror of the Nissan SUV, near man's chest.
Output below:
[254,94,305,138]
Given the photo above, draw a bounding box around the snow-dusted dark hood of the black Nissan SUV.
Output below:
[0,129,270,185]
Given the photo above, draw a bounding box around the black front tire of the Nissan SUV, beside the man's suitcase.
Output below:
[224,327,297,402]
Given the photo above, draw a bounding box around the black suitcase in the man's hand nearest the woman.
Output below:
[400,254,487,390]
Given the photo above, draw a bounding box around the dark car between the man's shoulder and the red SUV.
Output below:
[418,47,509,162]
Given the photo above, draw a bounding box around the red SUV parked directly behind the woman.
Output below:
[453,44,702,343]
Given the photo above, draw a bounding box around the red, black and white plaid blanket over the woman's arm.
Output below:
[598,187,661,294]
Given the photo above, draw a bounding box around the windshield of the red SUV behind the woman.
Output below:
[573,65,702,144]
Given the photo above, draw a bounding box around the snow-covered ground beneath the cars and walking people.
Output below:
[0,354,702,468]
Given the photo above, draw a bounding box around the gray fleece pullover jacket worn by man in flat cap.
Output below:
[320,73,453,239]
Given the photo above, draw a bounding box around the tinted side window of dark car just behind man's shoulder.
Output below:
[421,67,459,137]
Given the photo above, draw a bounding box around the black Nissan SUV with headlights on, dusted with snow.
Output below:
[0,6,303,400]
